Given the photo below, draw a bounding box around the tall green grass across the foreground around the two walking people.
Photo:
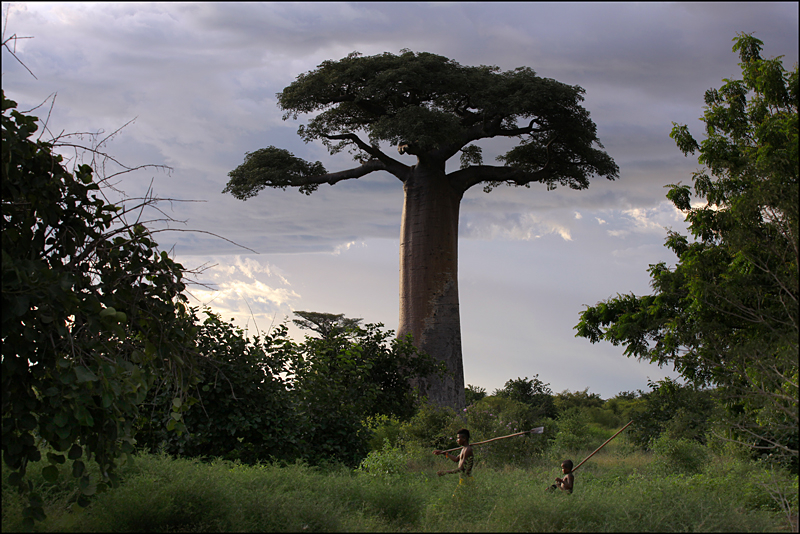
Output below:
[2,442,797,532]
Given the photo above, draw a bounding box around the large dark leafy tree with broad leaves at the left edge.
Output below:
[2,93,194,522]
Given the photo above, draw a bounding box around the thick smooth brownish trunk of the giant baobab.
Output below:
[398,165,465,409]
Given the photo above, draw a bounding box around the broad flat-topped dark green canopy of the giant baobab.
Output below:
[224,50,618,200]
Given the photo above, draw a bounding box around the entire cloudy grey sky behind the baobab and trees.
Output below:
[2,2,798,398]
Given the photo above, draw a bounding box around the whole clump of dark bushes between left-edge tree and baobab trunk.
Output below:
[136,311,446,472]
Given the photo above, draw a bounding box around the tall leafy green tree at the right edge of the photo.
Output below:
[576,34,799,462]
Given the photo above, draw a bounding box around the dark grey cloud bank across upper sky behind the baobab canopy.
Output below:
[4,3,797,258]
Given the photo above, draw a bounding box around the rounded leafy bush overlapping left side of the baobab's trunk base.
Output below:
[291,324,443,465]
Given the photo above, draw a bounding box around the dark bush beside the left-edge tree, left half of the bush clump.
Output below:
[136,310,302,463]
